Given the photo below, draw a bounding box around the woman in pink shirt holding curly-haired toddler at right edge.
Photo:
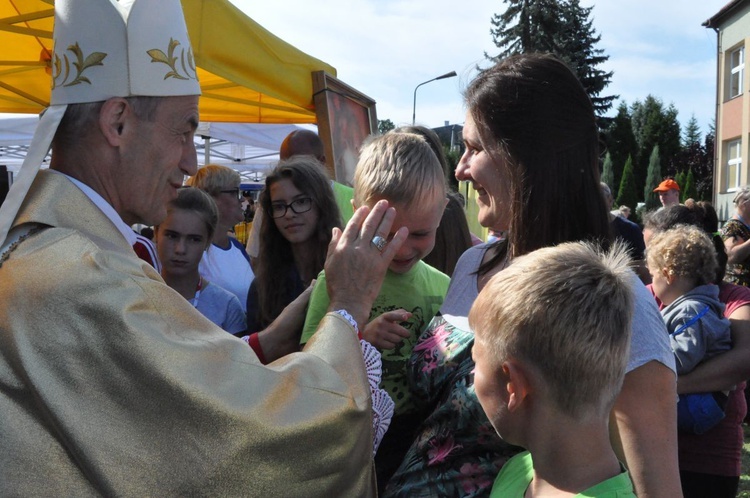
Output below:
[643,200,750,498]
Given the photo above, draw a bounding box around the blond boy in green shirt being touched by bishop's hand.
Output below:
[302,133,450,489]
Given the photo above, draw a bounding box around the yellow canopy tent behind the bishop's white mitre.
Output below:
[0,0,336,123]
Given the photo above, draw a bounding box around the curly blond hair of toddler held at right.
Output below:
[646,225,719,285]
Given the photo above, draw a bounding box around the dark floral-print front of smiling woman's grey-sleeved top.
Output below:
[383,245,522,497]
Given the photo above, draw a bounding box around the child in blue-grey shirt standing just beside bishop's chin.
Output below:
[156,187,247,335]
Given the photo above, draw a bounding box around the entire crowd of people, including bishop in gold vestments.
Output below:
[0,0,750,498]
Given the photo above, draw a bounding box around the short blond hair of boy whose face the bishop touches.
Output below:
[354,133,446,206]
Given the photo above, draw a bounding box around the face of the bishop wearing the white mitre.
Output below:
[117,96,198,225]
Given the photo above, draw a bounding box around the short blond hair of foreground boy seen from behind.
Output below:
[469,242,636,420]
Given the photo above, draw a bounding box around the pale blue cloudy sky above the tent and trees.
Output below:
[239,0,728,140]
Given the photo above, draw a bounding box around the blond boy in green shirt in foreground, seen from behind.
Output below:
[469,242,638,498]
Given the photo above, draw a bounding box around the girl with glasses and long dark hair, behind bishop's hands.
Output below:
[247,156,341,332]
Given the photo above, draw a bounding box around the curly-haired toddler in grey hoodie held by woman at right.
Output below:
[647,225,732,434]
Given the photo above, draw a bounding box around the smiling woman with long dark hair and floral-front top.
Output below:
[384,54,681,497]
